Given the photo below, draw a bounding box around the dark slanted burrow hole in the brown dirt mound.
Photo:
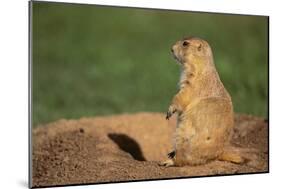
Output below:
[108,133,146,161]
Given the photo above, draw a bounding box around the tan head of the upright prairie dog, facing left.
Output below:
[171,37,213,66]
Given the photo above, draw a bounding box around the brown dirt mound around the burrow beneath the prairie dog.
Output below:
[32,113,268,187]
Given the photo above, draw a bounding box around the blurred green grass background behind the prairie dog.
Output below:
[32,2,268,126]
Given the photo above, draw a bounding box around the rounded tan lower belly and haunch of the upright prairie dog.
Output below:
[175,97,233,165]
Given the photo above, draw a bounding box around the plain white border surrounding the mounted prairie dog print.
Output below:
[0,0,281,189]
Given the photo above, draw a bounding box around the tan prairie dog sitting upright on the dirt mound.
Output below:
[161,37,244,166]
